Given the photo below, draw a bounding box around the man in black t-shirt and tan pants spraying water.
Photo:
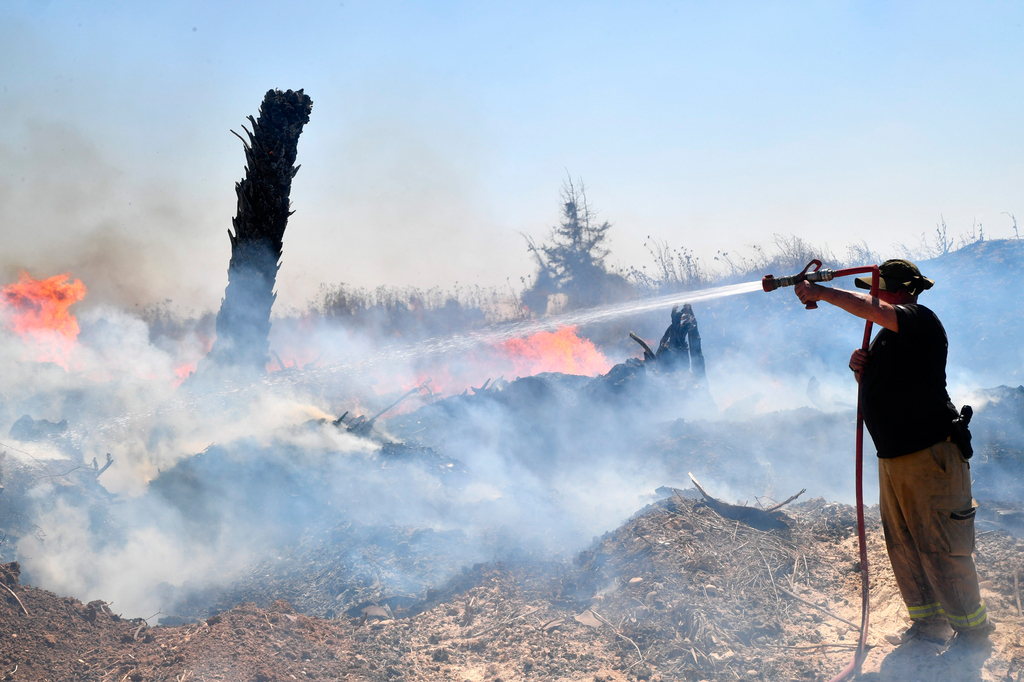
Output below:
[796,259,993,648]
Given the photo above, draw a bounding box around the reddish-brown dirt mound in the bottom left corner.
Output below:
[0,563,377,682]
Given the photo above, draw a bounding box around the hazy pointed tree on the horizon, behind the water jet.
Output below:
[522,176,633,312]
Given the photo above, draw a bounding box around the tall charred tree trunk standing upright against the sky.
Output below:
[201,90,312,373]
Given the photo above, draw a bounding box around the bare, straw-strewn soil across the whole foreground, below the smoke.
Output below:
[0,496,1024,682]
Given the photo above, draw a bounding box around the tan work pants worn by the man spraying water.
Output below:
[879,441,987,630]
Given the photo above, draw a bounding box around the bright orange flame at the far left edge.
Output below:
[0,272,87,370]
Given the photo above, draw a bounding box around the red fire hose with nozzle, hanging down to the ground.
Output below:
[761,260,879,682]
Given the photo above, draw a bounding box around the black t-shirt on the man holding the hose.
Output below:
[861,303,956,459]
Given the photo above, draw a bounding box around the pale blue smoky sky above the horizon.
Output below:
[0,0,1024,308]
